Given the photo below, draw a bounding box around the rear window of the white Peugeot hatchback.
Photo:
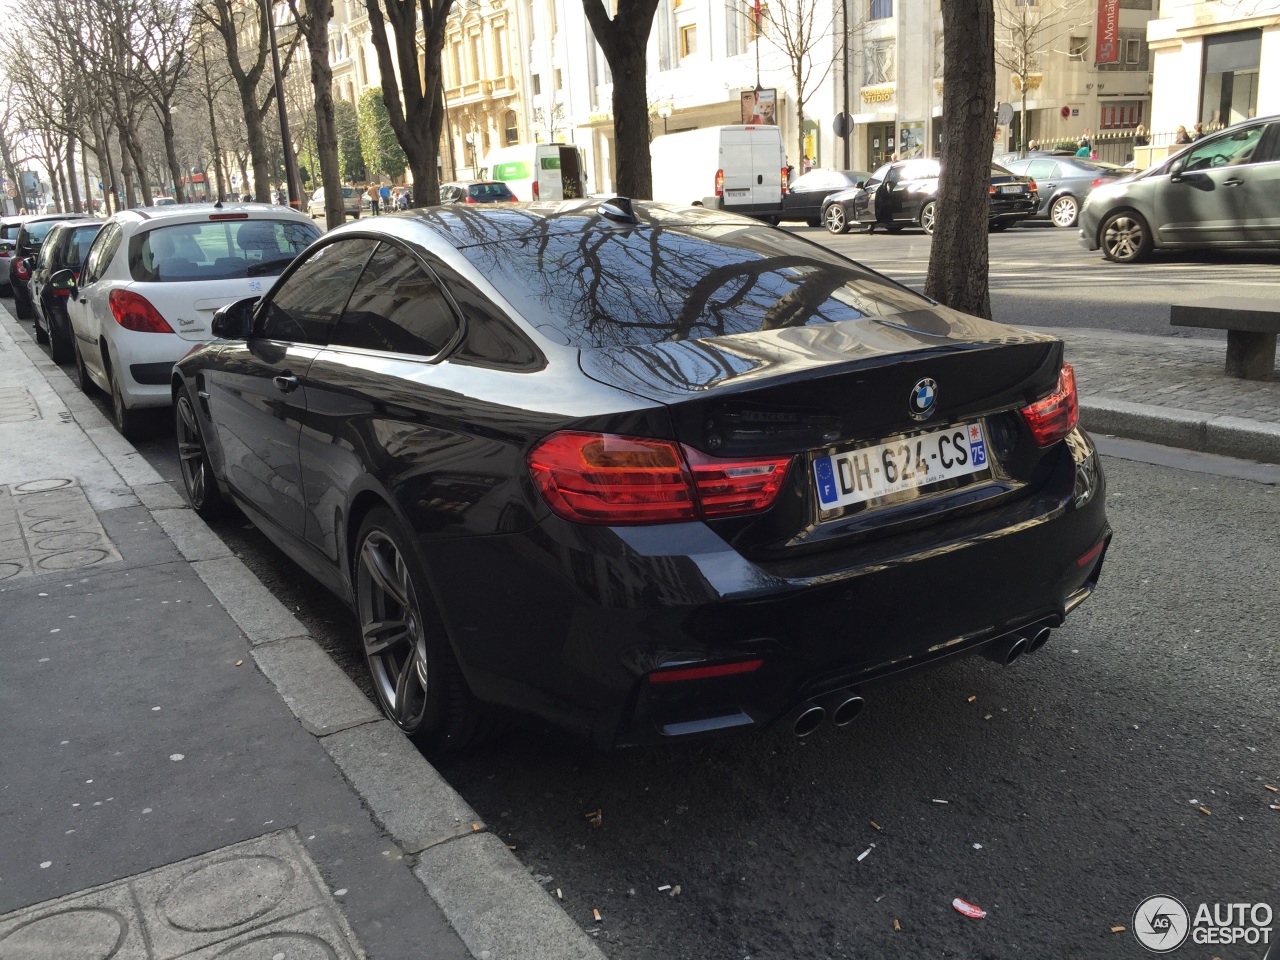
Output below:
[129,220,320,283]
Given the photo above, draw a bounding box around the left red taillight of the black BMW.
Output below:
[529,431,791,525]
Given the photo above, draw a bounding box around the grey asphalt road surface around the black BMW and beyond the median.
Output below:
[17,228,1280,960]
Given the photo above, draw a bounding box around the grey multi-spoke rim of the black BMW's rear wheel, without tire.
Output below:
[357,529,431,733]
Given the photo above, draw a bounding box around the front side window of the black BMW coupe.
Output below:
[255,237,378,347]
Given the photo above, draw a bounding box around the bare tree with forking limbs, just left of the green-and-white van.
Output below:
[365,0,453,206]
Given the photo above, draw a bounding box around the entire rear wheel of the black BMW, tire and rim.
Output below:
[352,507,481,754]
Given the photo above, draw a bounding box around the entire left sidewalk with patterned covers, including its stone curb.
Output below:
[0,310,603,960]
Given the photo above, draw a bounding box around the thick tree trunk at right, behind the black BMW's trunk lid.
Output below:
[924,0,996,319]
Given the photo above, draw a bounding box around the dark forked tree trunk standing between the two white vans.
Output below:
[582,0,658,200]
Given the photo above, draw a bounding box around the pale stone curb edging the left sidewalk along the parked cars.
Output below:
[0,310,605,960]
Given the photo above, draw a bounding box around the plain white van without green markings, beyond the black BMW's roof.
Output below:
[649,124,787,223]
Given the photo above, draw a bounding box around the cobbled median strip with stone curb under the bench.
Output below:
[1029,326,1280,463]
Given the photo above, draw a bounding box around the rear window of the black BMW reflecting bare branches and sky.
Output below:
[462,213,925,348]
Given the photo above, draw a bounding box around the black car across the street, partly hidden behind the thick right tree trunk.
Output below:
[822,157,1037,233]
